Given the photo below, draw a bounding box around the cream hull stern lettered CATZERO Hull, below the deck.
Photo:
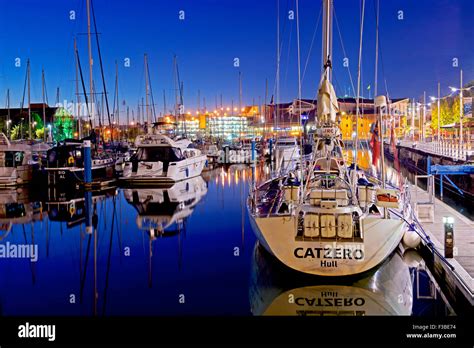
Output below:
[250,214,406,276]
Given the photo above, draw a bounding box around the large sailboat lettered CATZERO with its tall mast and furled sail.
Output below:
[247,0,409,276]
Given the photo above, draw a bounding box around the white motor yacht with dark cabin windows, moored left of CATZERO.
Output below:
[120,134,207,184]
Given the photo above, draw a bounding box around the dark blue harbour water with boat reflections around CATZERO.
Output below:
[0,165,453,316]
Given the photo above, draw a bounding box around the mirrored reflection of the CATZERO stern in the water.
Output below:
[249,244,413,316]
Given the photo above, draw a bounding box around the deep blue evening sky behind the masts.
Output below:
[0,0,474,111]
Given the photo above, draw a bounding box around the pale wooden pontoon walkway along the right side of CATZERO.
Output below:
[411,186,474,305]
